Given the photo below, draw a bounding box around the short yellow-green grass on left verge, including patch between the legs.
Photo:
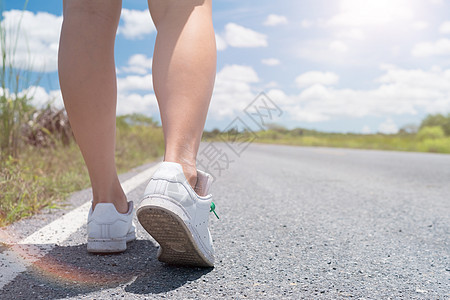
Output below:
[0,125,164,226]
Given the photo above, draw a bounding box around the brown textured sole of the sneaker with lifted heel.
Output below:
[136,199,214,267]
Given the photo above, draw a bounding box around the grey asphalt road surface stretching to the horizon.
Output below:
[0,144,450,299]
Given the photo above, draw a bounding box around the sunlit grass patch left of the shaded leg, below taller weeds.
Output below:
[0,144,89,226]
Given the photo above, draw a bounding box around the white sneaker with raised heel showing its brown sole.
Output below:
[137,162,218,267]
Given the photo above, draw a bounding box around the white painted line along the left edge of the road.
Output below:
[0,164,159,289]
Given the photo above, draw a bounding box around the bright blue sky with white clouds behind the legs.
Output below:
[3,0,450,133]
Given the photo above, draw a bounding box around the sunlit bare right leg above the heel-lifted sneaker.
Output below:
[148,0,216,186]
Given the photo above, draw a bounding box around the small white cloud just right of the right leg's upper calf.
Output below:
[224,23,268,48]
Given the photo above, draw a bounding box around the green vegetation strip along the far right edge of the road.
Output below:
[204,114,450,153]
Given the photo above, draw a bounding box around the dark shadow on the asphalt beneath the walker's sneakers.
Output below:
[0,240,212,299]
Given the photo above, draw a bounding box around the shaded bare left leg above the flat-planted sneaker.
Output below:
[58,0,128,213]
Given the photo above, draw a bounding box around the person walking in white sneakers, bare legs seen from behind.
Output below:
[58,0,216,267]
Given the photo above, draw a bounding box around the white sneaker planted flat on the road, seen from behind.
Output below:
[87,201,136,253]
